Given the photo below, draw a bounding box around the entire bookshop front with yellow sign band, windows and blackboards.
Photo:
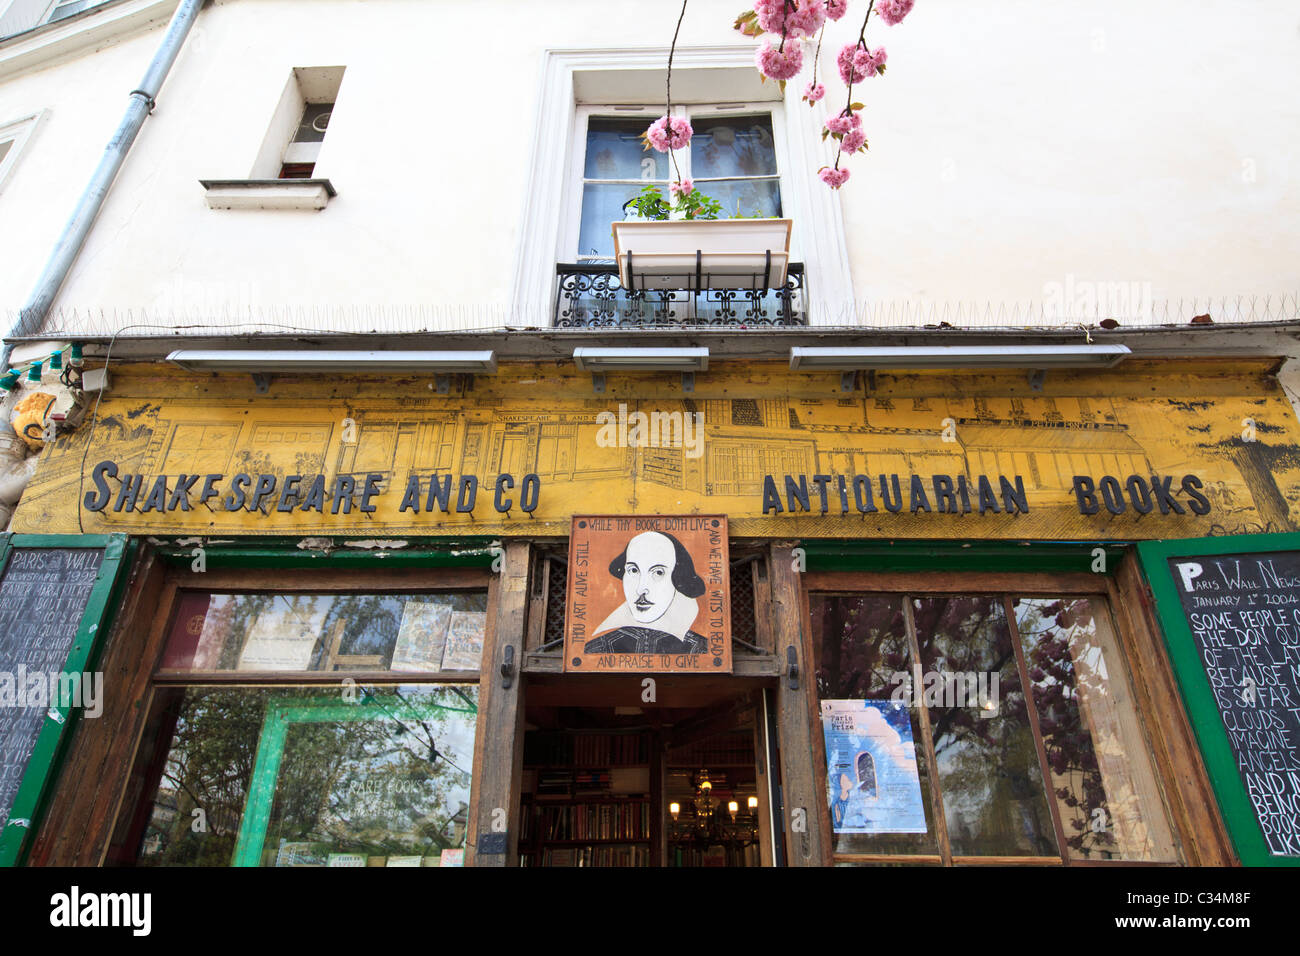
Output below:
[0,359,1300,866]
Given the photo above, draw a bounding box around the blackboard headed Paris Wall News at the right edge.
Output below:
[1165,551,1300,857]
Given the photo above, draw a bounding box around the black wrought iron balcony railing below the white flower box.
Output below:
[554,263,807,329]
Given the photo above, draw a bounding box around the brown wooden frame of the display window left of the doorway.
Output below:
[30,561,508,866]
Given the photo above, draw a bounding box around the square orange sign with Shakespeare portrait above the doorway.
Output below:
[564,515,732,674]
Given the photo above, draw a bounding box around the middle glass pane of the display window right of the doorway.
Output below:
[913,596,1057,856]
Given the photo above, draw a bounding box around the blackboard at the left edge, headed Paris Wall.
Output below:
[0,548,104,827]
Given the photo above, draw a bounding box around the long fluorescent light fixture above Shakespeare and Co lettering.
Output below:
[166,349,497,375]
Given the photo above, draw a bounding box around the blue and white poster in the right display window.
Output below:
[822,700,927,834]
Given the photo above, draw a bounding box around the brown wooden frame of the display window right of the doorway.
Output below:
[800,571,1190,868]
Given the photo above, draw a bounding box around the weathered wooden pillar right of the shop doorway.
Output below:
[770,542,831,866]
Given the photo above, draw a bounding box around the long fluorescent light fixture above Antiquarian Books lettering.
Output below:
[790,345,1131,371]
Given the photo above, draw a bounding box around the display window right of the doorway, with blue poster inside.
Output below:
[807,575,1179,865]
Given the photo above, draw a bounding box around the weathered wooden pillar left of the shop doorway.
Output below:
[465,541,532,866]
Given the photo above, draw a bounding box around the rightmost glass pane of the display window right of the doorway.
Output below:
[1013,597,1175,861]
